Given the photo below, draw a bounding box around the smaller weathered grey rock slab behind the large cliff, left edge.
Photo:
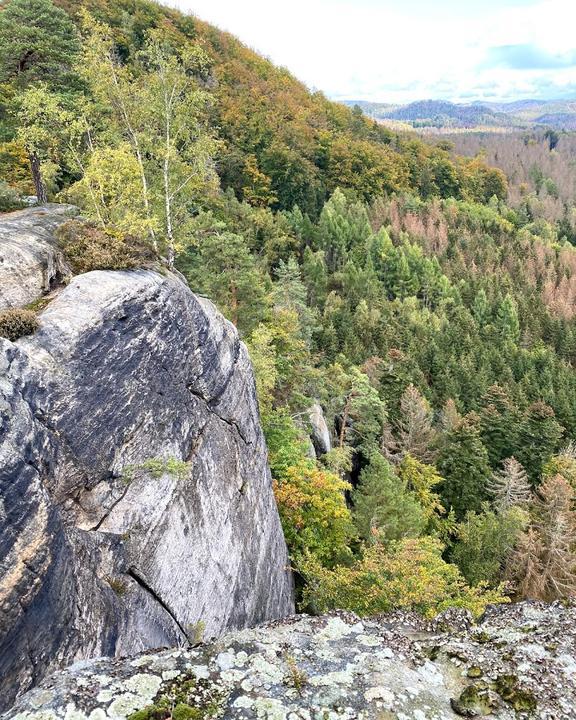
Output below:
[0,205,75,311]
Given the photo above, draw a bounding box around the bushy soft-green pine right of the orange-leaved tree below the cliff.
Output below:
[352,453,426,541]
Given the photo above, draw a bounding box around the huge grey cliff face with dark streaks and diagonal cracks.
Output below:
[0,207,293,706]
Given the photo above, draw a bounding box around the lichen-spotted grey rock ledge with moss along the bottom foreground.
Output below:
[5,603,576,720]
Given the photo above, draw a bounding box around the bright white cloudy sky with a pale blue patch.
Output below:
[164,0,576,103]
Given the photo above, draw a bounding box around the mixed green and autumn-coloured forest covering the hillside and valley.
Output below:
[0,0,576,614]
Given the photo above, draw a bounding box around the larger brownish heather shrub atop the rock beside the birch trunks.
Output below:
[56,220,155,273]
